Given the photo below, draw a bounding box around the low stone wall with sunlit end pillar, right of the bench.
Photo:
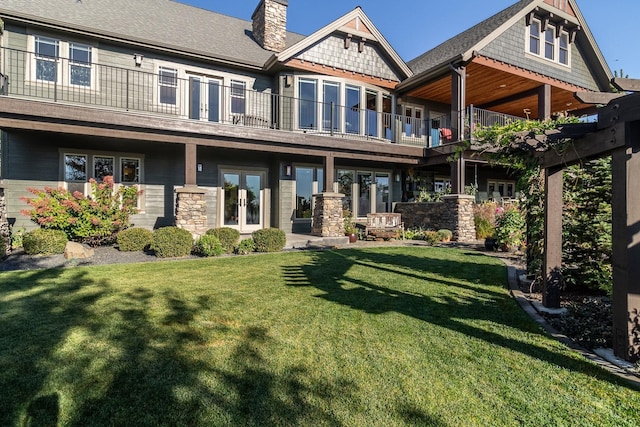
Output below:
[394,194,476,242]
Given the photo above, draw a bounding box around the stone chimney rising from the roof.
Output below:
[251,0,288,52]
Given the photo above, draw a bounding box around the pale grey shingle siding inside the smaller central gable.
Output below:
[297,35,402,81]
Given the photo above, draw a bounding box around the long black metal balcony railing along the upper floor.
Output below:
[0,48,520,147]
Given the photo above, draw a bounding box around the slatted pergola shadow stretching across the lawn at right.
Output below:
[284,249,635,390]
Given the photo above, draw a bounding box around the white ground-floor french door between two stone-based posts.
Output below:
[221,171,265,233]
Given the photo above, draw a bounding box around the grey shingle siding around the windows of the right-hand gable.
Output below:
[480,19,599,91]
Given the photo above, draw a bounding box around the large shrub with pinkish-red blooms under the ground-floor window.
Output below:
[21,176,138,246]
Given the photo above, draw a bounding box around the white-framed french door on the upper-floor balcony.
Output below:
[189,76,222,122]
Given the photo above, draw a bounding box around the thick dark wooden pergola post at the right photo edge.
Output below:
[612,121,640,362]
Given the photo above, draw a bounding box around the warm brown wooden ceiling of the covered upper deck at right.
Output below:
[408,56,594,119]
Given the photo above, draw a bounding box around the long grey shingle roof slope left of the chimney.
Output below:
[0,0,305,67]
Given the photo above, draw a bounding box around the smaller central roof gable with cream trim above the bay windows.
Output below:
[266,7,413,86]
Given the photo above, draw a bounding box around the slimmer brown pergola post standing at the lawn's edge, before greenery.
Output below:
[542,166,562,308]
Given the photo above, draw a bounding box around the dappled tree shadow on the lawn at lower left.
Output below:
[0,269,357,426]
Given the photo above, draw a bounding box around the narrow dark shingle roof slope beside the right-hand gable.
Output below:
[407,0,535,75]
